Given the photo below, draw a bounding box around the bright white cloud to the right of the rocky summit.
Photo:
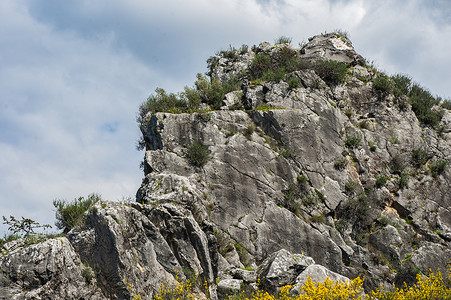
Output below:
[352,1,451,96]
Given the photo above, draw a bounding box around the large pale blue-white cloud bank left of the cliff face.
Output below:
[0,1,165,231]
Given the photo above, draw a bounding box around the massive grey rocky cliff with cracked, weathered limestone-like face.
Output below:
[0,33,451,299]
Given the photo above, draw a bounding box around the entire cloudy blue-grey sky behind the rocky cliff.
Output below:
[0,0,451,236]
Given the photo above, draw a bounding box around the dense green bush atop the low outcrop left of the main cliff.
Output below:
[53,194,102,233]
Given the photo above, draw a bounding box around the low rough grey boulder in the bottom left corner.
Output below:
[0,237,105,299]
